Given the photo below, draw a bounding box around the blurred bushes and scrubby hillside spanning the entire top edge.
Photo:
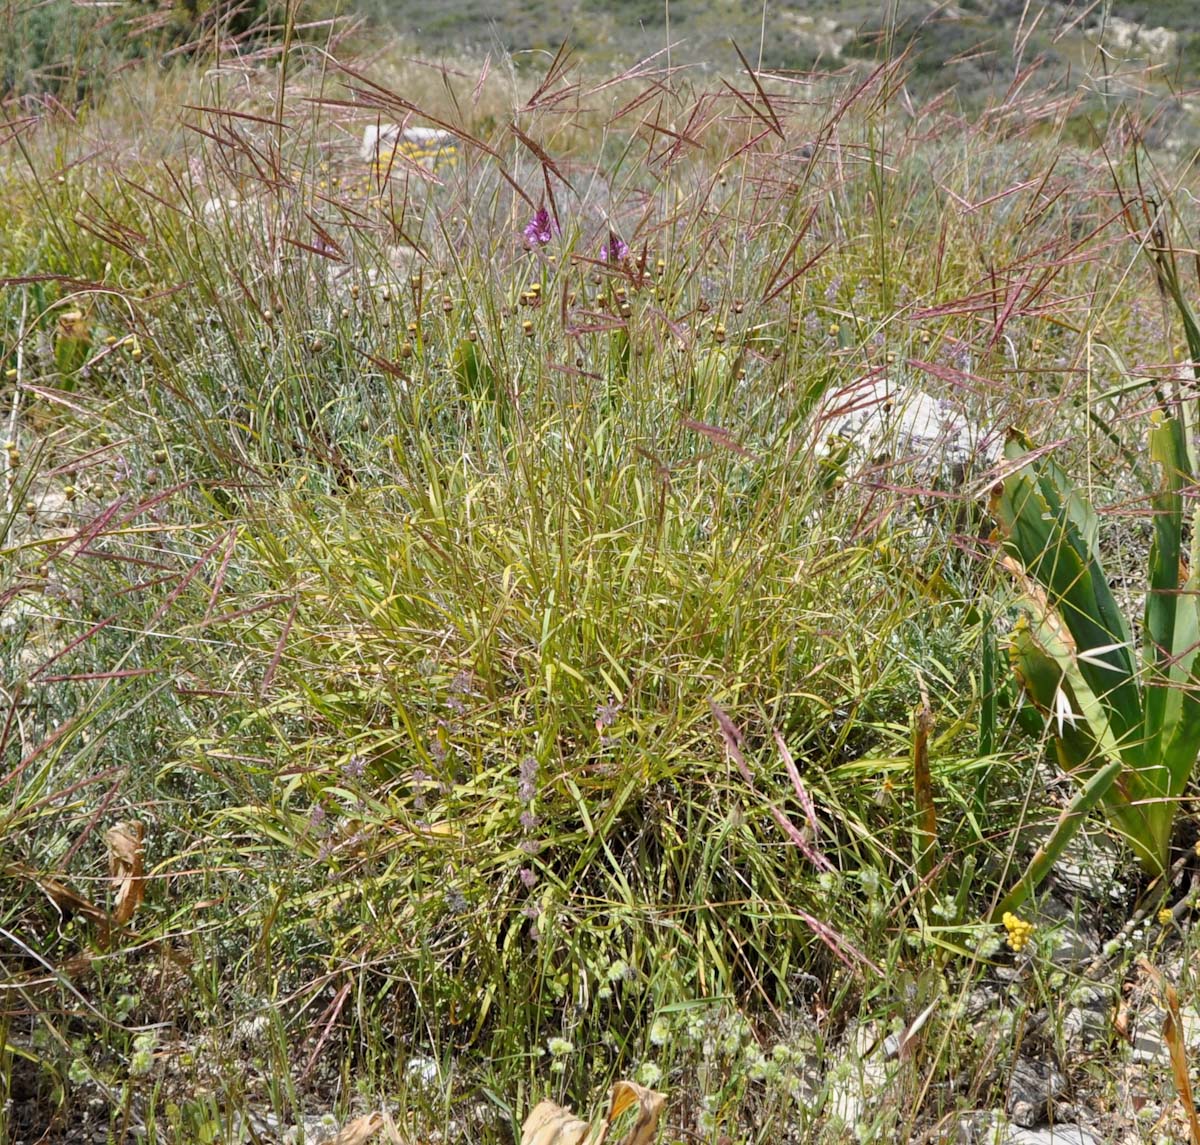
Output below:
[7,0,1200,108]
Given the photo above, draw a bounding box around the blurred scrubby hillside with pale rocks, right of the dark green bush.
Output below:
[358,0,1200,131]
